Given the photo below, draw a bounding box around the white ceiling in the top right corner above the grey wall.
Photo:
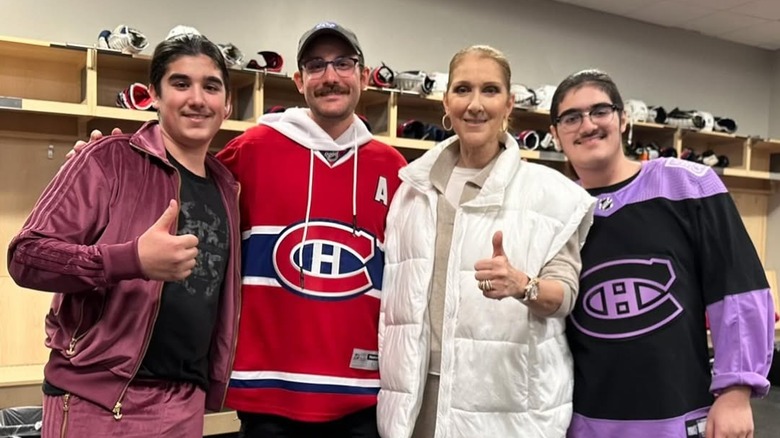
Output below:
[555,0,780,50]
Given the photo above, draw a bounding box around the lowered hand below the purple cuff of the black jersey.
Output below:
[705,386,753,438]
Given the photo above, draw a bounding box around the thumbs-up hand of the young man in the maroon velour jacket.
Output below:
[138,199,198,281]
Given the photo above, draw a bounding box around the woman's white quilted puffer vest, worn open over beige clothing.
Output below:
[377,136,594,438]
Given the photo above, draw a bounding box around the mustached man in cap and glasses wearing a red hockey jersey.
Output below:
[218,22,405,438]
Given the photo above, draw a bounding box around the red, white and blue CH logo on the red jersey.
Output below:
[272,221,383,300]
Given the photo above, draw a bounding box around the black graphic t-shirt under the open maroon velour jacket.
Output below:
[138,154,229,389]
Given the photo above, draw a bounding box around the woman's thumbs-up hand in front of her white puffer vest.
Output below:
[474,231,528,300]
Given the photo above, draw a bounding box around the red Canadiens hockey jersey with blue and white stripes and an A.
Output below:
[219,125,406,422]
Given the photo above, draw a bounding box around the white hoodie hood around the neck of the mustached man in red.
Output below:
[258,108,373,152]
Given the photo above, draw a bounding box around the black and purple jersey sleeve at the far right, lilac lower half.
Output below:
[695,170,775,397]
